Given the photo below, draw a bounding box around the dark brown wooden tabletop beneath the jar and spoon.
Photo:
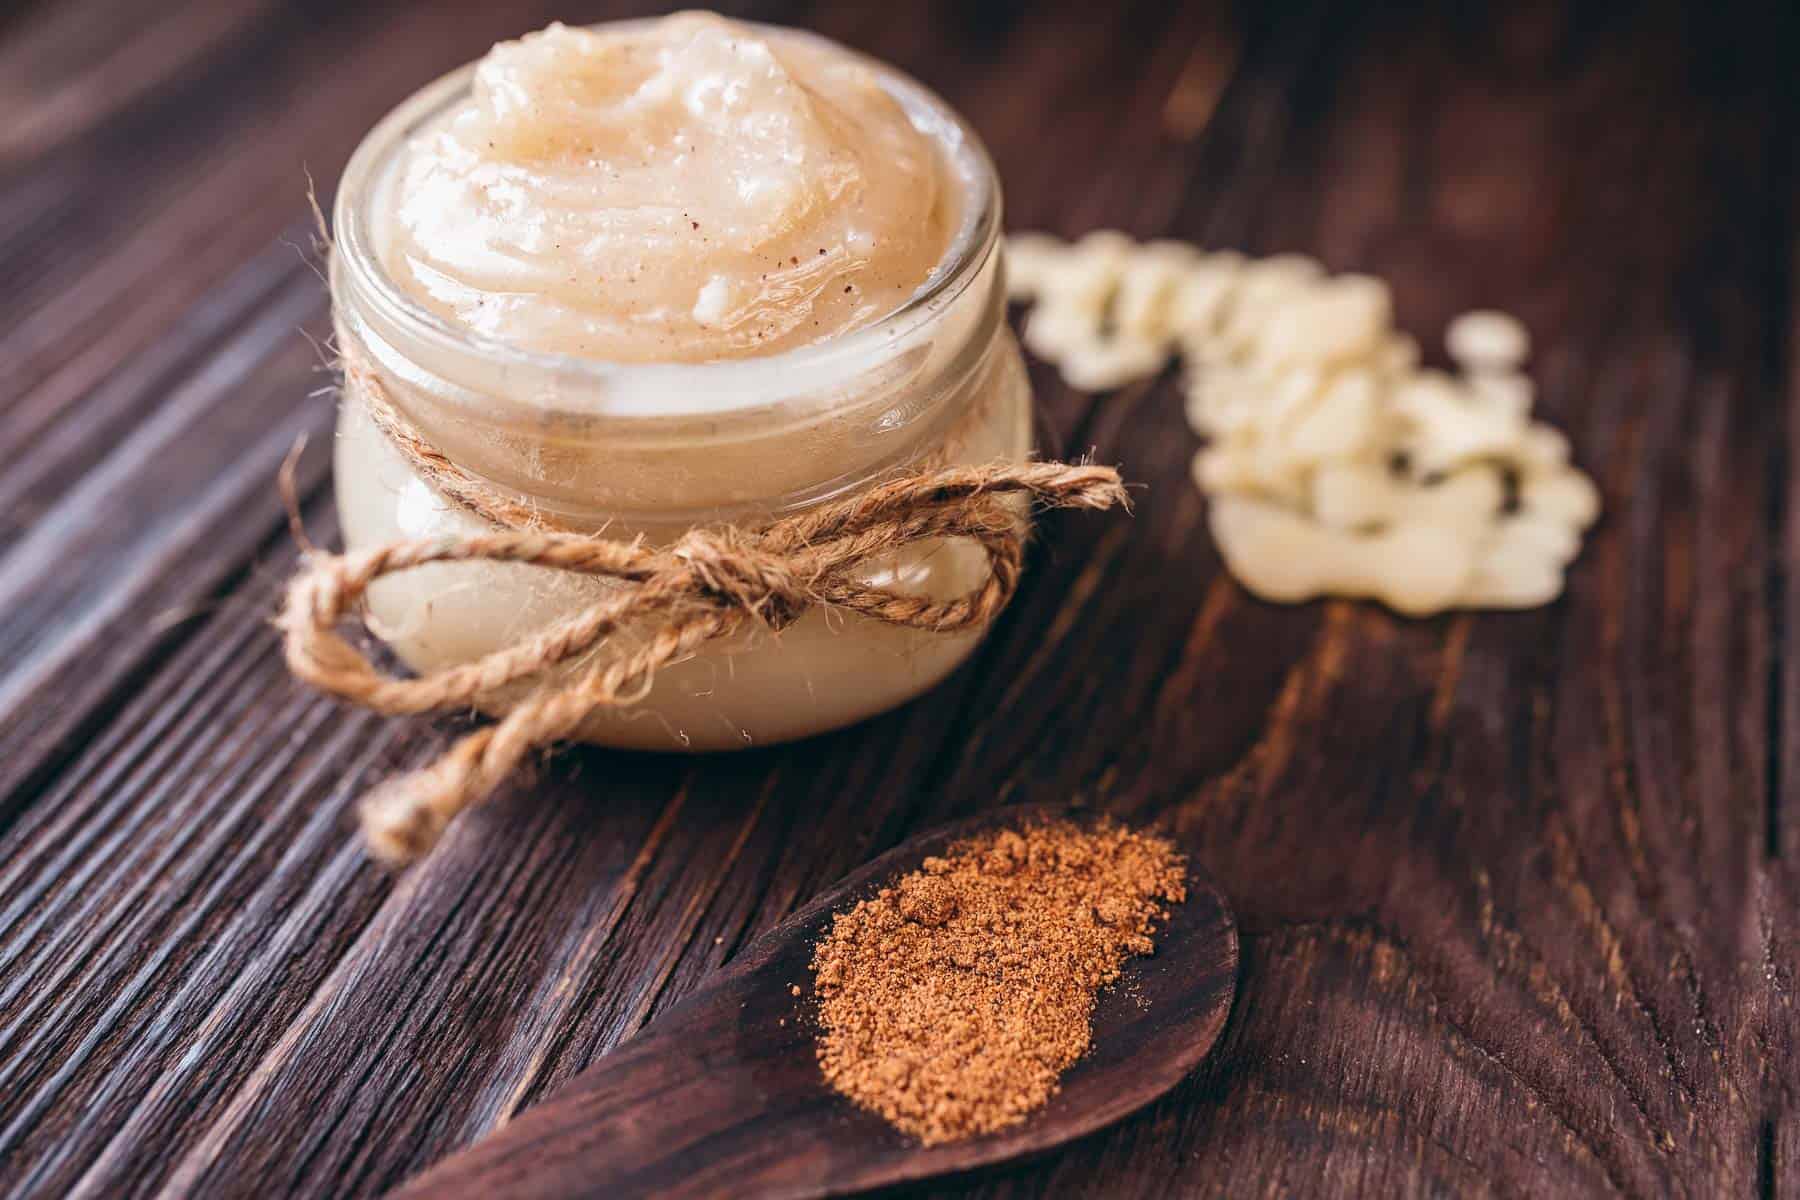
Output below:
[0,0,1800,1196]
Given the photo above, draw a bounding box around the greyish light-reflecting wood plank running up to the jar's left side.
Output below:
[0,266,331,826]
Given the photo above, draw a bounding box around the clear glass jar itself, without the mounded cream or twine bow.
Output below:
[331,25,1031,750]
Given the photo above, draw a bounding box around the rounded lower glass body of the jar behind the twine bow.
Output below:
[337,335,1030,750]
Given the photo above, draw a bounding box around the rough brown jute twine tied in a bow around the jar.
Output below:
[277,365,1125,864]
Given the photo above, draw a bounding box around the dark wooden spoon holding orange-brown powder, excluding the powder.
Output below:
[398,806,1237,1200]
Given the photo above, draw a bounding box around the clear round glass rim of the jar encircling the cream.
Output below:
[331,18,1001,416]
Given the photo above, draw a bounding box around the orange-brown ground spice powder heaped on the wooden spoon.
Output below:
[812,819,1186,1146]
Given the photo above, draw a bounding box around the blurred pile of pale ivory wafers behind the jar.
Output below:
[1006,232,1600,615]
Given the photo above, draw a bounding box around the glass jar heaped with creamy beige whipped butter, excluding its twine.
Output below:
[331,14,1030,750]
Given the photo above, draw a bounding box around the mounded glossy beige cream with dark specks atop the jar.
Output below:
[378,13,959,362]
